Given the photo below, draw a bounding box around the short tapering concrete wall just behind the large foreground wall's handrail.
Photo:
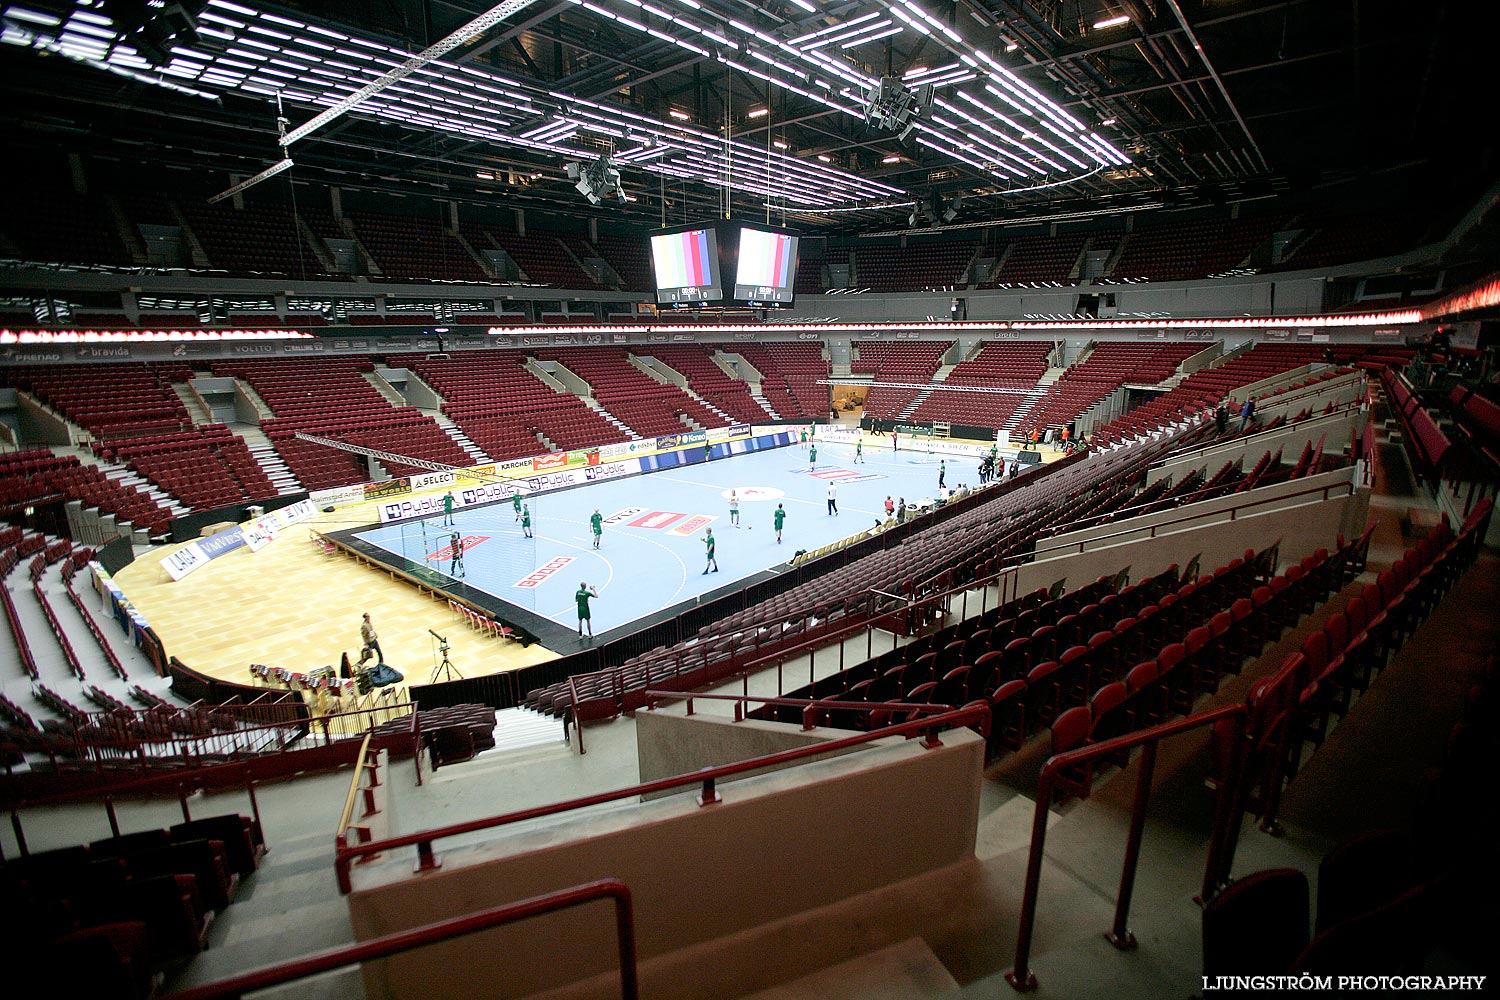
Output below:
[636,709,870,799]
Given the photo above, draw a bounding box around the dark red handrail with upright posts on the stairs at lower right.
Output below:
[1005,703,1248,993]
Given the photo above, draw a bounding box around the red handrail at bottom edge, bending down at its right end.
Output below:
[162,879,641,1000]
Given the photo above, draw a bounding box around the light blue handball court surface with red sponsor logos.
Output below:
[353,442,978,634]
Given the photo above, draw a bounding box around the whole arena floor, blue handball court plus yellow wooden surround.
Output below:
[116,435,1026,684]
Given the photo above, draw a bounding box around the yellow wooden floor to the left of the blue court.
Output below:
[114,491,557,684]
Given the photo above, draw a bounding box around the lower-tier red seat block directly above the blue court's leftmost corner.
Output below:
[213,355,471,490]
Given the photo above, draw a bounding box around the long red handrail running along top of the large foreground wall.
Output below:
[333,702,990,895]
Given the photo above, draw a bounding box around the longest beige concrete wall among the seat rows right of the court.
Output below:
[1016,469,1370,594]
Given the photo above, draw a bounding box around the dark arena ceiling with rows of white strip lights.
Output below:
[0,0,1494,229]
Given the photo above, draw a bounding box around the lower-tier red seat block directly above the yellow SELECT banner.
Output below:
[387,351,630,460]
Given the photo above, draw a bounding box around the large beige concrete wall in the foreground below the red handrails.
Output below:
[348,730,984,1000]
